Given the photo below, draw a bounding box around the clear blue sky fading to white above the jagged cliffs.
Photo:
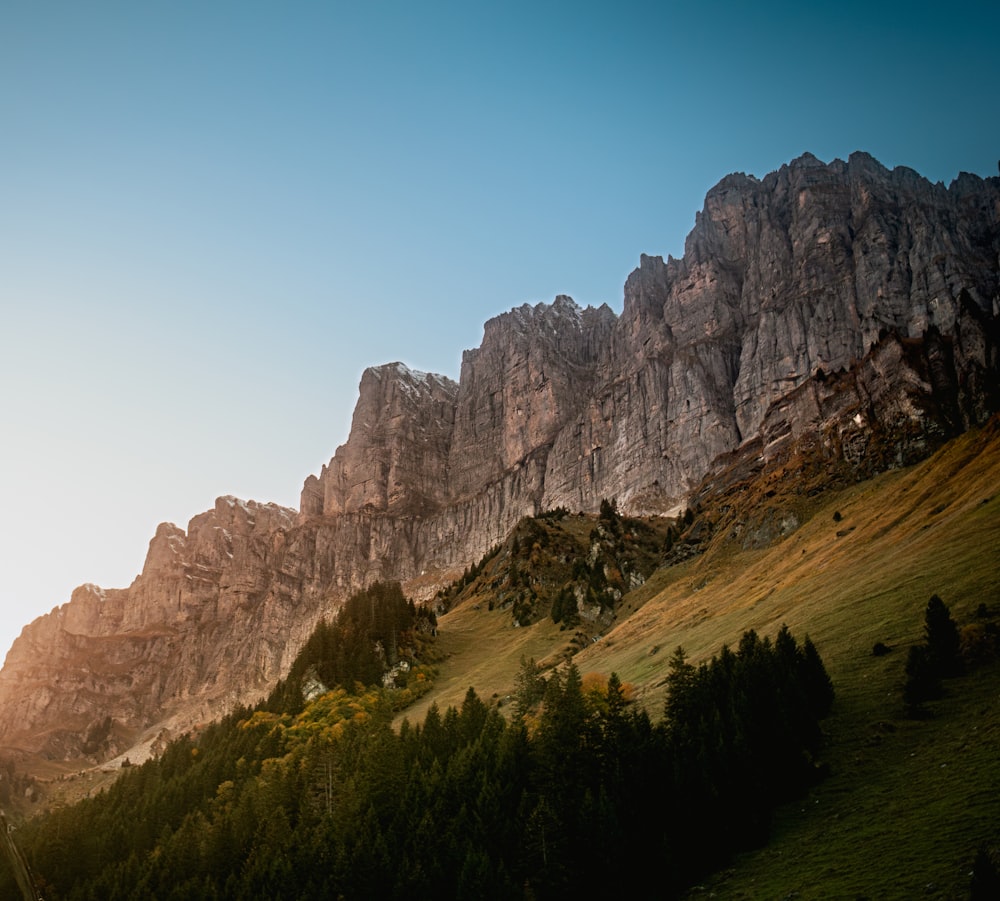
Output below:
[0,0,1000,657]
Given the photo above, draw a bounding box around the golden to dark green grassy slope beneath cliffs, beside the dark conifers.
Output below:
[408,424,1000,899]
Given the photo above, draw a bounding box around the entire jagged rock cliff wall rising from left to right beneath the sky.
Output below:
[0,154,1000,757]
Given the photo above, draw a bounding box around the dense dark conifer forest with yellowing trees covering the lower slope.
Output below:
[0,586,832,901]
